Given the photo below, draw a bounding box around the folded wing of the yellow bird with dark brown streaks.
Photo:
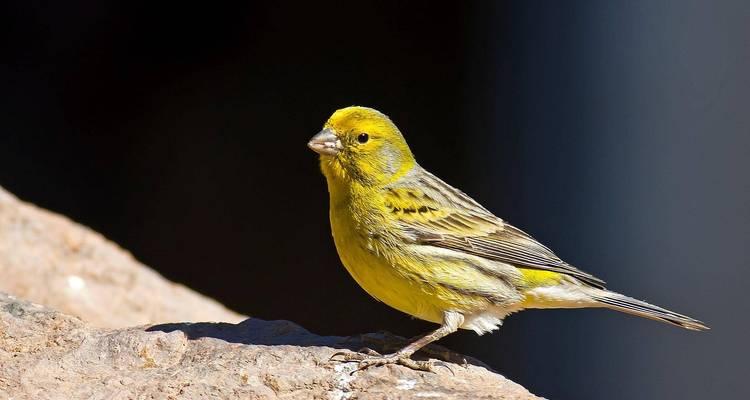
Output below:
[384,167,604,288]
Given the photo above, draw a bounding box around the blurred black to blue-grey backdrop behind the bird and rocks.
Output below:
[0,1,750,399]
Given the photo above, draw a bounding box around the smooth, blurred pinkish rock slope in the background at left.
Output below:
[0,188,245,327]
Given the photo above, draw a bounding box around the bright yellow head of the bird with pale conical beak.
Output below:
[307,107,416,186]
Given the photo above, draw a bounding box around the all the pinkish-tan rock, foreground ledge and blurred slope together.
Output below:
[0,188,537,400]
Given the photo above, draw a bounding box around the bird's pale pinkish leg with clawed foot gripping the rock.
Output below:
[331,311,464,372]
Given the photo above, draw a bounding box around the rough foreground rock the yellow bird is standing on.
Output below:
[0,293,537,400]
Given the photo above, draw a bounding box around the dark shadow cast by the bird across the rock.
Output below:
[146,318,490,369]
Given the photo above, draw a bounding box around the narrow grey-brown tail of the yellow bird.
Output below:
[592,290,709,331]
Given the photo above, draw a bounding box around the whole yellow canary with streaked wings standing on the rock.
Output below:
[308,107,708,370]
